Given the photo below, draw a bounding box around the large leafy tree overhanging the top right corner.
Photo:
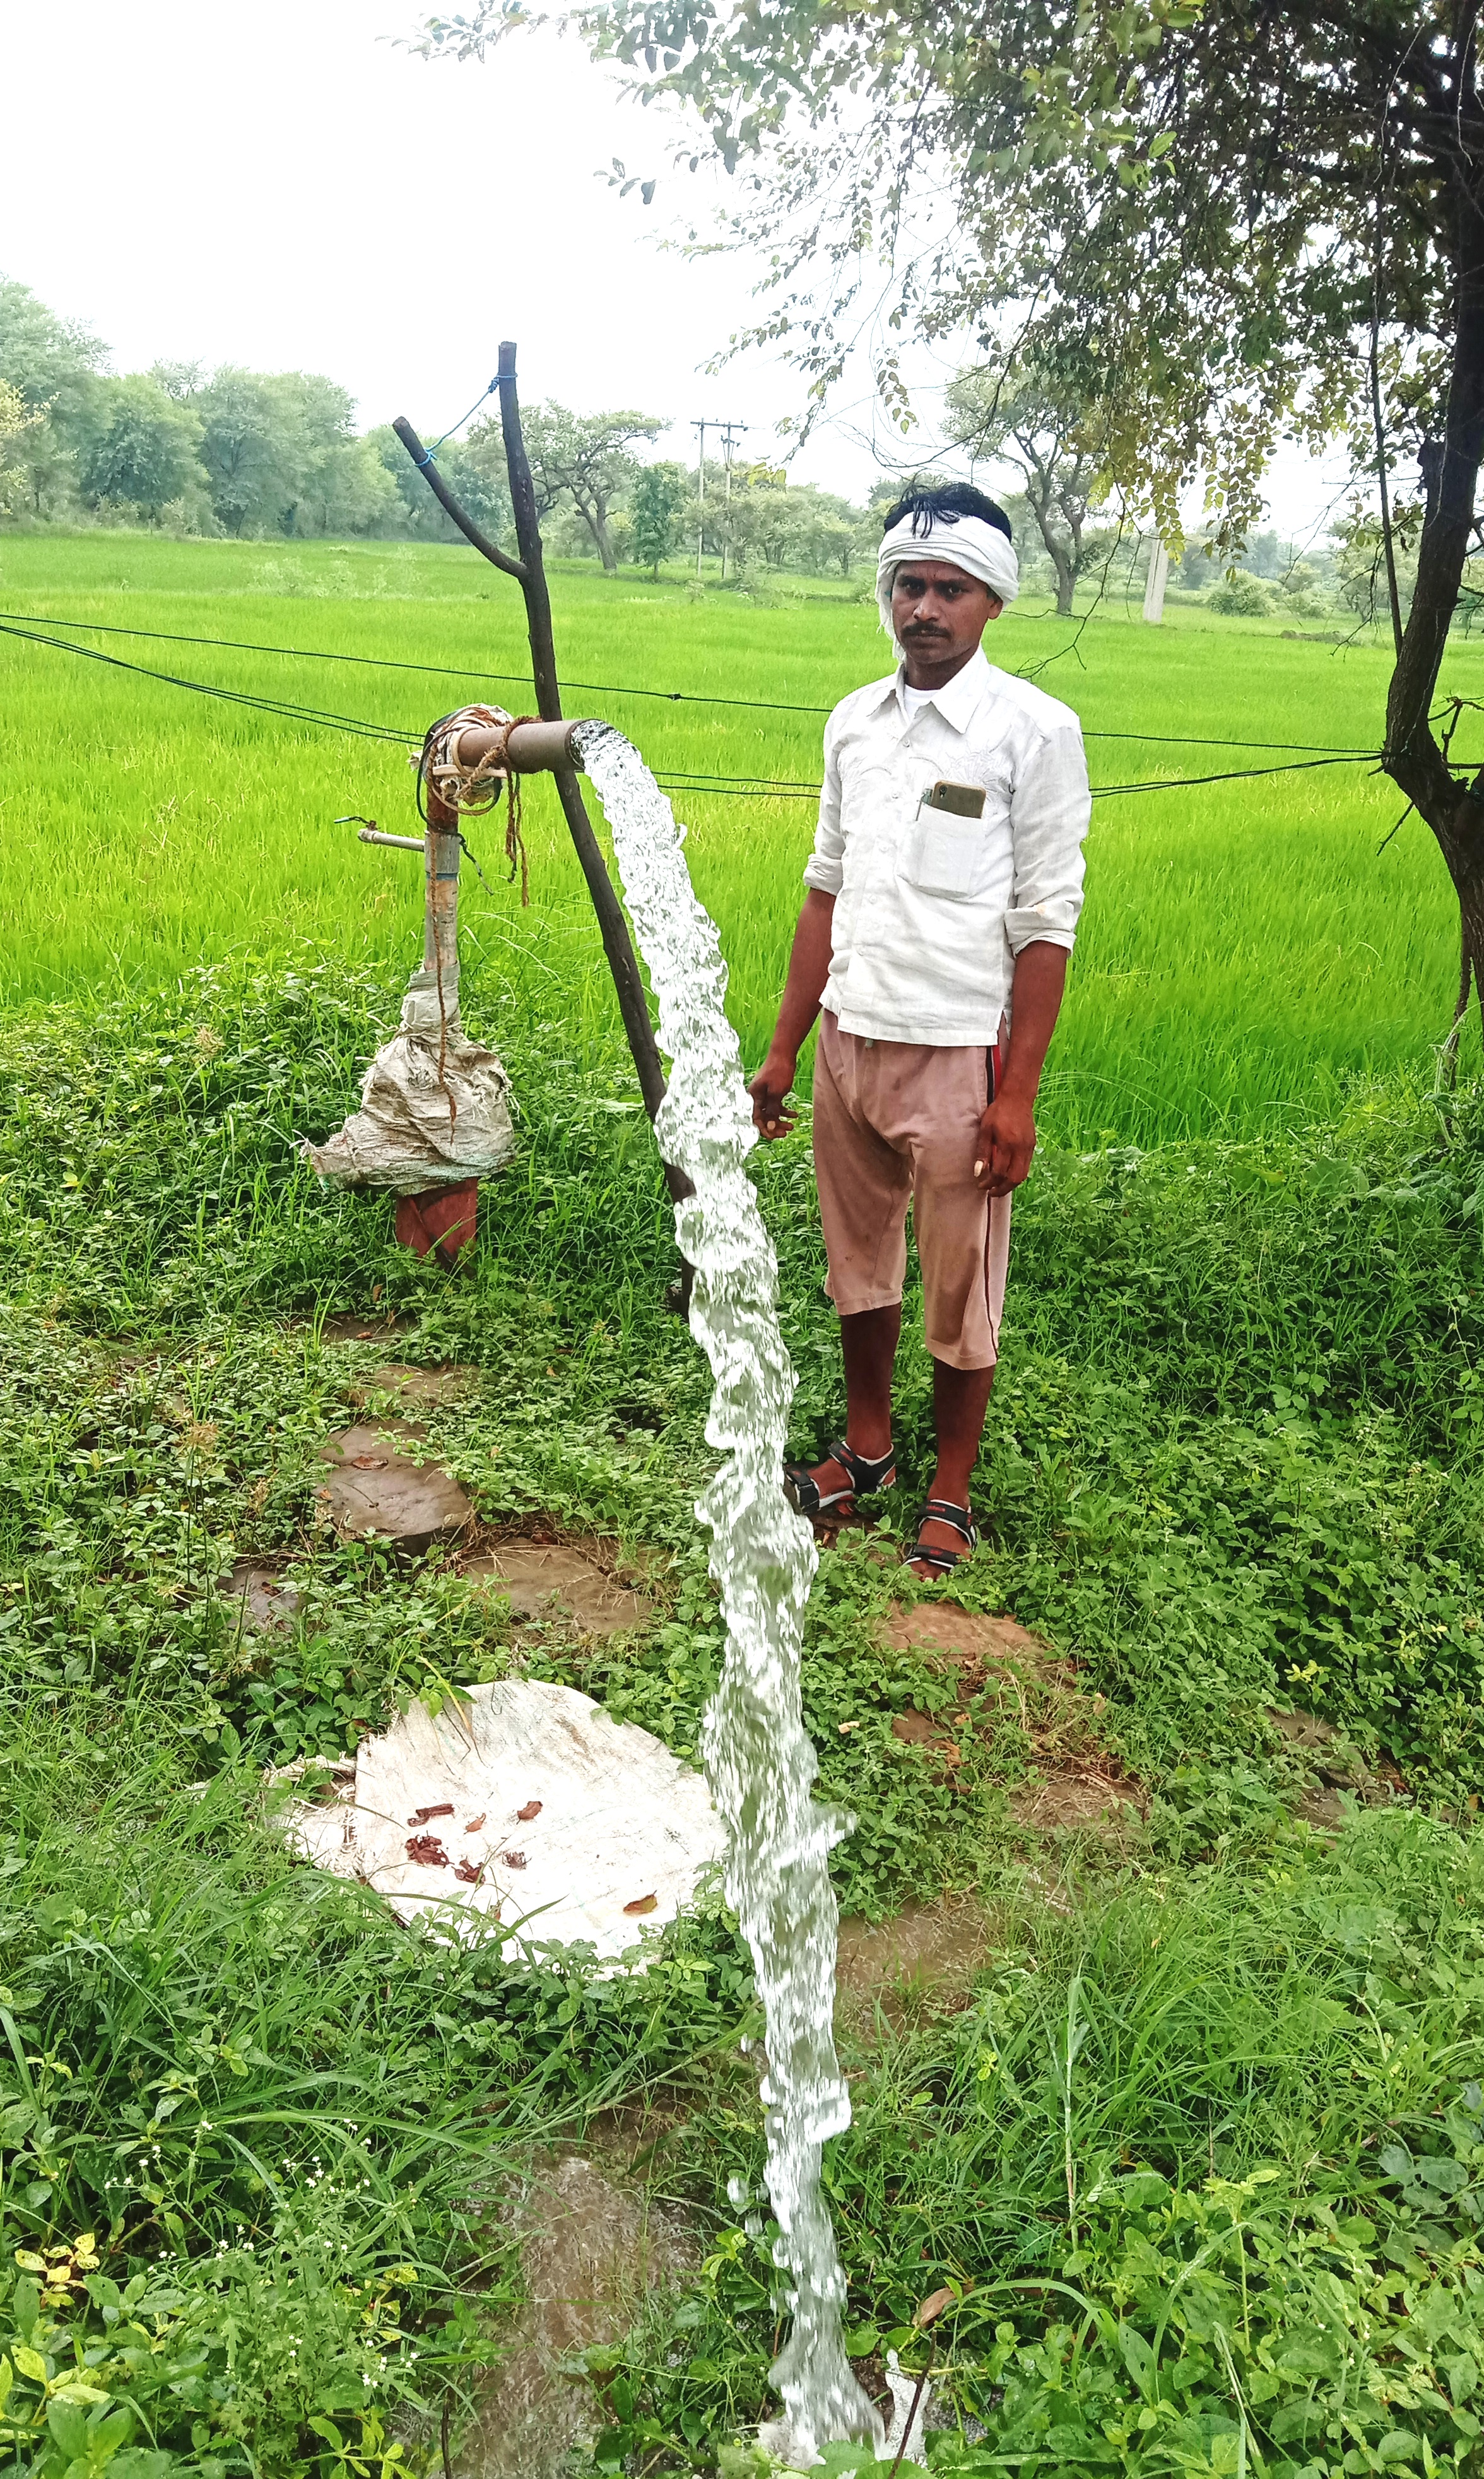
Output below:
[426,0,1484,1051]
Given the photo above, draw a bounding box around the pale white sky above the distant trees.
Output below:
[0,0,1328,531]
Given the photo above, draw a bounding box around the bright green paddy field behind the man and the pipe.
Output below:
[0,535,1484,1145]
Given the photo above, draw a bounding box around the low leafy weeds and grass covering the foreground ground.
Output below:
[0,949,1484,2479]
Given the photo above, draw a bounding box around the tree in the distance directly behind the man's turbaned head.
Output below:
[949,355,1107,617]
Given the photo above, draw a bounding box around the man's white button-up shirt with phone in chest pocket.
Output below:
[803,652,1093,1049]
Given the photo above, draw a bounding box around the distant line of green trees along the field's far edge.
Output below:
[0,278,1387,625]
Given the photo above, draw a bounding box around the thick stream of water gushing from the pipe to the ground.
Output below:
[577,724,882,2462]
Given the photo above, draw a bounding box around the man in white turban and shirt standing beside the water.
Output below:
[751,483,1090,1577]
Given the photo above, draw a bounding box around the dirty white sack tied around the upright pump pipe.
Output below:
[302,972,515,1197]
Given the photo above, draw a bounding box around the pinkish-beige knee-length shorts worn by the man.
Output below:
[815,1014,1011,1368]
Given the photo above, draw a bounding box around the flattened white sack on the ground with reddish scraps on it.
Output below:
[287,1678,724,1961]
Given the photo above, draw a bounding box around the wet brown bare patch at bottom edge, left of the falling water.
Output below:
[454,2157,698,2479]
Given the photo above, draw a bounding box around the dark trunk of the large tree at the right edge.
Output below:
[1382,165,1484,1056]
